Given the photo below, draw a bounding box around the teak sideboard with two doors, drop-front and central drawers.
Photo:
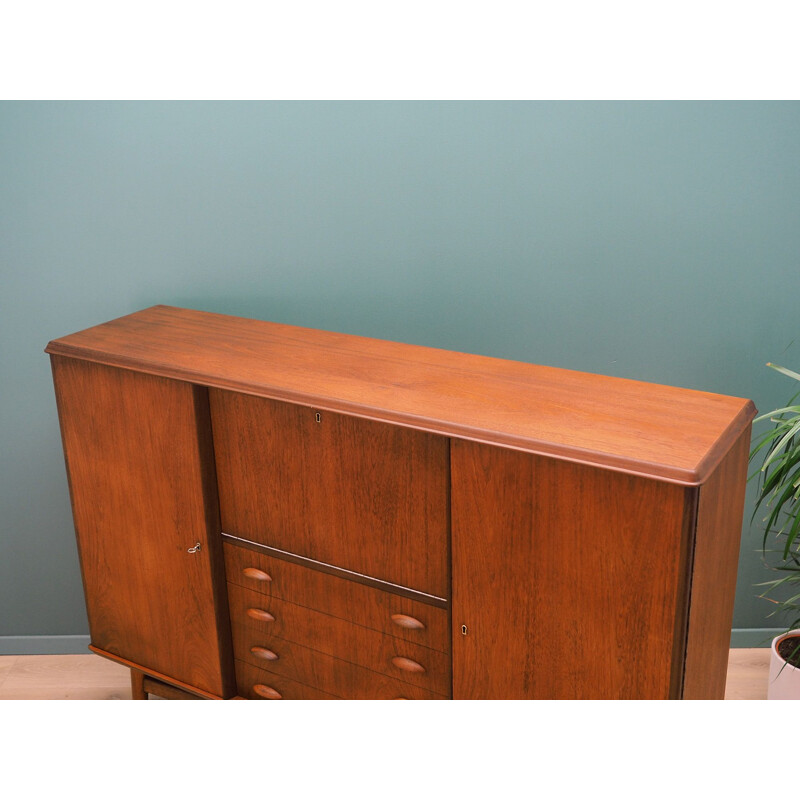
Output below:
[46,306,755,699]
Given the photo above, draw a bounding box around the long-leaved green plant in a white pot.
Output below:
[750,364,800,700]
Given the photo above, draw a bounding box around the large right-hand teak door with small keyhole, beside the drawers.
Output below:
[451,440,686,699]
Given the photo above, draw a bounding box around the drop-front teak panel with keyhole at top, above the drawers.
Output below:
[209,389,449,597]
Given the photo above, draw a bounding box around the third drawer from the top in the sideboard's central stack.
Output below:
[233,625,450,700]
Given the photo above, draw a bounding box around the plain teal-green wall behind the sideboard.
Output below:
[0,102,800,652]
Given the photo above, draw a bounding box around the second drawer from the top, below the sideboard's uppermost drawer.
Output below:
[228,584,450,694]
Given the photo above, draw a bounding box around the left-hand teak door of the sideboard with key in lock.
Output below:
[52,356,233,696]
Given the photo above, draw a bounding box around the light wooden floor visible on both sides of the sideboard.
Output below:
[0,648,769,700]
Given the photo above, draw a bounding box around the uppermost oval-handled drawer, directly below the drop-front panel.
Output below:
[225,542,450,653]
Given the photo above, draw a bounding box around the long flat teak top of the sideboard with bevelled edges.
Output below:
[46,306,756,486]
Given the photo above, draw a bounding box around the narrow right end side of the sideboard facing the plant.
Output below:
[683,429,750,700]
